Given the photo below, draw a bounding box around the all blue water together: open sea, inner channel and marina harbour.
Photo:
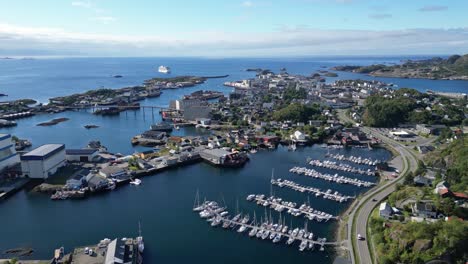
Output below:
[0,55,454,263]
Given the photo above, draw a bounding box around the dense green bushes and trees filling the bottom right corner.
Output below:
[369,217,468,264]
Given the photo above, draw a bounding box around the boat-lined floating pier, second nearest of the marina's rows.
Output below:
[247,194,338,222]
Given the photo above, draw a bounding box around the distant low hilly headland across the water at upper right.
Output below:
[332,54,468,80]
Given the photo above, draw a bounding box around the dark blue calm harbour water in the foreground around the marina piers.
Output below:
[0,146,389,263]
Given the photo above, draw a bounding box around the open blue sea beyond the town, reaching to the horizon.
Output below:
[0,57,468,102]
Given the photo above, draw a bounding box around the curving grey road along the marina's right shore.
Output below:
[339,111,418,264]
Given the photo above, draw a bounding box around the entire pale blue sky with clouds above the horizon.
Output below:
[0,0,468,57]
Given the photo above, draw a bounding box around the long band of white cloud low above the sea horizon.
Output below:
[0,22,468,57]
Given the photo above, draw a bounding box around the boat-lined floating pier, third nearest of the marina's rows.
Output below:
[271,179,356,203]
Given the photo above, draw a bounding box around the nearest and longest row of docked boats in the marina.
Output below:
[193,201,326,251]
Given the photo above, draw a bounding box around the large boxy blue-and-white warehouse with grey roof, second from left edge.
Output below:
[20,144,65,179]
